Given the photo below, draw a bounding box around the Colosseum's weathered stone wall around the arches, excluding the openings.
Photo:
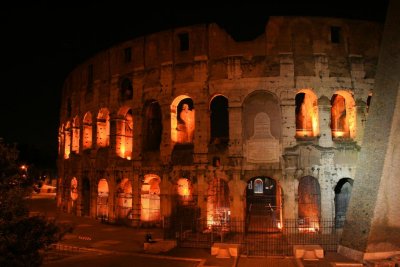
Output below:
[58,17,382,227]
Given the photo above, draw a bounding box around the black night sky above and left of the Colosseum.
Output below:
[0,0,388,170]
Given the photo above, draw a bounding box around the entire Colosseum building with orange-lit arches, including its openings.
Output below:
[57,16,383,255]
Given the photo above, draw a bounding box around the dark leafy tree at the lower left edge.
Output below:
[0,139,71,267]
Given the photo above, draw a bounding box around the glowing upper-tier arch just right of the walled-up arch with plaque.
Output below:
[295,89,319,138]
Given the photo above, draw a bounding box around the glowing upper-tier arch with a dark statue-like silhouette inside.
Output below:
[171,95,195,144]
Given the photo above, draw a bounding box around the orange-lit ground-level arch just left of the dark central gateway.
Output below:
[207,177,231,227]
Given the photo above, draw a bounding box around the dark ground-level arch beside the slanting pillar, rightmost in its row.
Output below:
[335,178,353,228]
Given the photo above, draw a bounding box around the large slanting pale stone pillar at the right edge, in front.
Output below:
[338,0,400,261]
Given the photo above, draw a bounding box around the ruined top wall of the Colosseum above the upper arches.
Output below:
[63,17,383,117]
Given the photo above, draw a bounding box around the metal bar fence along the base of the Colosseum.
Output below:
[164,218,339,256]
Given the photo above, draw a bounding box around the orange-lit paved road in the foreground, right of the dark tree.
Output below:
[29,198,360,267]
